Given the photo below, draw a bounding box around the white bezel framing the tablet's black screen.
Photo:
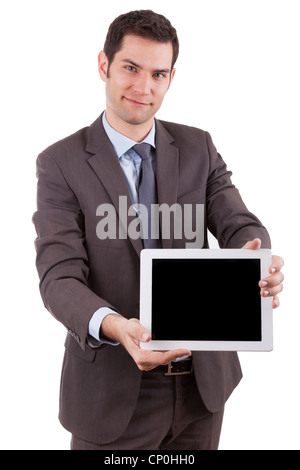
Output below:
[140,249,273,351]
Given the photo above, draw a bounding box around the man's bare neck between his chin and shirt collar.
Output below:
[106,108,154,142]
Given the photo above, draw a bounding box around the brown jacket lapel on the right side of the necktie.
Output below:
[156,120,179,248]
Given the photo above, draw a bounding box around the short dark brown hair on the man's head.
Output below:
[104,10,179,69]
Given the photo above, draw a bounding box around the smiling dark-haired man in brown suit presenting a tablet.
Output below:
[34,10,283,450]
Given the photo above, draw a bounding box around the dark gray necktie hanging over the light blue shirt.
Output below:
[132,143,161,248]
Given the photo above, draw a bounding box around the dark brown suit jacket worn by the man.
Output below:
[33,116,270,444]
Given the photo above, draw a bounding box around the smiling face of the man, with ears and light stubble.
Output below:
[99,35,175,133]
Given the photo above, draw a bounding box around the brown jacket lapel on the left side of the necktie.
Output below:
[86,115,143,255]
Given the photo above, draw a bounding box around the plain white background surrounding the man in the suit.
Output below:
[0,0,300,450]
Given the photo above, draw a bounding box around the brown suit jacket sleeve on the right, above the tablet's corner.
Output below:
[206,132,271,248]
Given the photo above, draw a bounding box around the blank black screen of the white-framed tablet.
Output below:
[152,258,262,341]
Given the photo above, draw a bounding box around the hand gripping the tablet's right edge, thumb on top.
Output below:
[243,238,284,308]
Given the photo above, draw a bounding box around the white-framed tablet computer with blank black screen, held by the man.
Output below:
[140,249,273,351]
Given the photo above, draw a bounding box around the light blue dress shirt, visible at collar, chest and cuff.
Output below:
[89,113,155,345]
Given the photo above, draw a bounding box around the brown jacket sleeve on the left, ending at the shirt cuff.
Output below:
[33,152,117,349]
